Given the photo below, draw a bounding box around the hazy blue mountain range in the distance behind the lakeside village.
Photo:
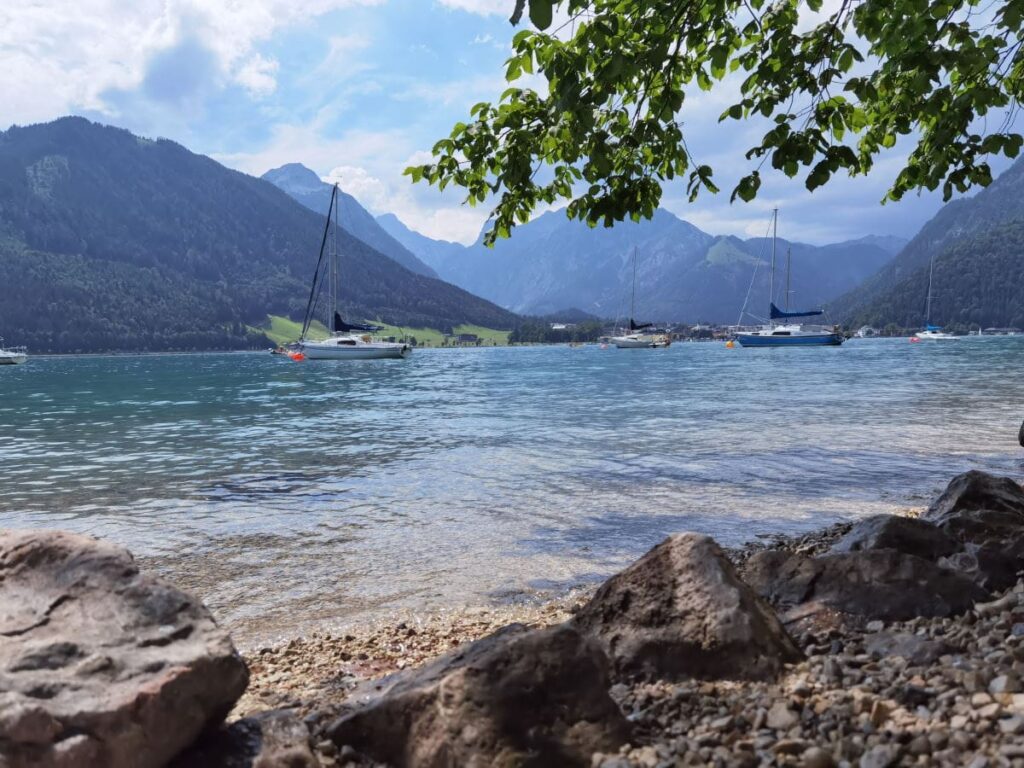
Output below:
[378,210,902,323]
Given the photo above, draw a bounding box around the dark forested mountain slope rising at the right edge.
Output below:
[835,161,1024,328]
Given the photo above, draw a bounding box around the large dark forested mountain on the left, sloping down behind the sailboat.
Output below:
[0,118,516,351]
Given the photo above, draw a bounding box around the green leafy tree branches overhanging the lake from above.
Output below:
[406,0,1024,244]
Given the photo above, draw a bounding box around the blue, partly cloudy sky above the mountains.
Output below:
[0,0,1006,244]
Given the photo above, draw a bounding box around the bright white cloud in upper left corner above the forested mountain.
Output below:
[0,0,384,123]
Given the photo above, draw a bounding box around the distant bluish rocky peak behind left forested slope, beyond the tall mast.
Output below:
[261,163,437,278]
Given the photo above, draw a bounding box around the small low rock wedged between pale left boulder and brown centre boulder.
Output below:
[170,710,319,768]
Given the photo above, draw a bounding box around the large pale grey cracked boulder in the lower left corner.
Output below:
[0,530,249,768]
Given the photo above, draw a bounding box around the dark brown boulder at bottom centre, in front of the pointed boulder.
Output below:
[326,625,629,768]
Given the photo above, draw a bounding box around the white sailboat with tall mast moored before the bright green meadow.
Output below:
[293,184,412,360]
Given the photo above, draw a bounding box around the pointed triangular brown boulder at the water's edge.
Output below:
[573,534,802,680]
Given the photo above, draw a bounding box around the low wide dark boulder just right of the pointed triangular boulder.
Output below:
[743,549,988,624]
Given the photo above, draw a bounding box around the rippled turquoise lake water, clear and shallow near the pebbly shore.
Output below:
[0,338,1024,641]
